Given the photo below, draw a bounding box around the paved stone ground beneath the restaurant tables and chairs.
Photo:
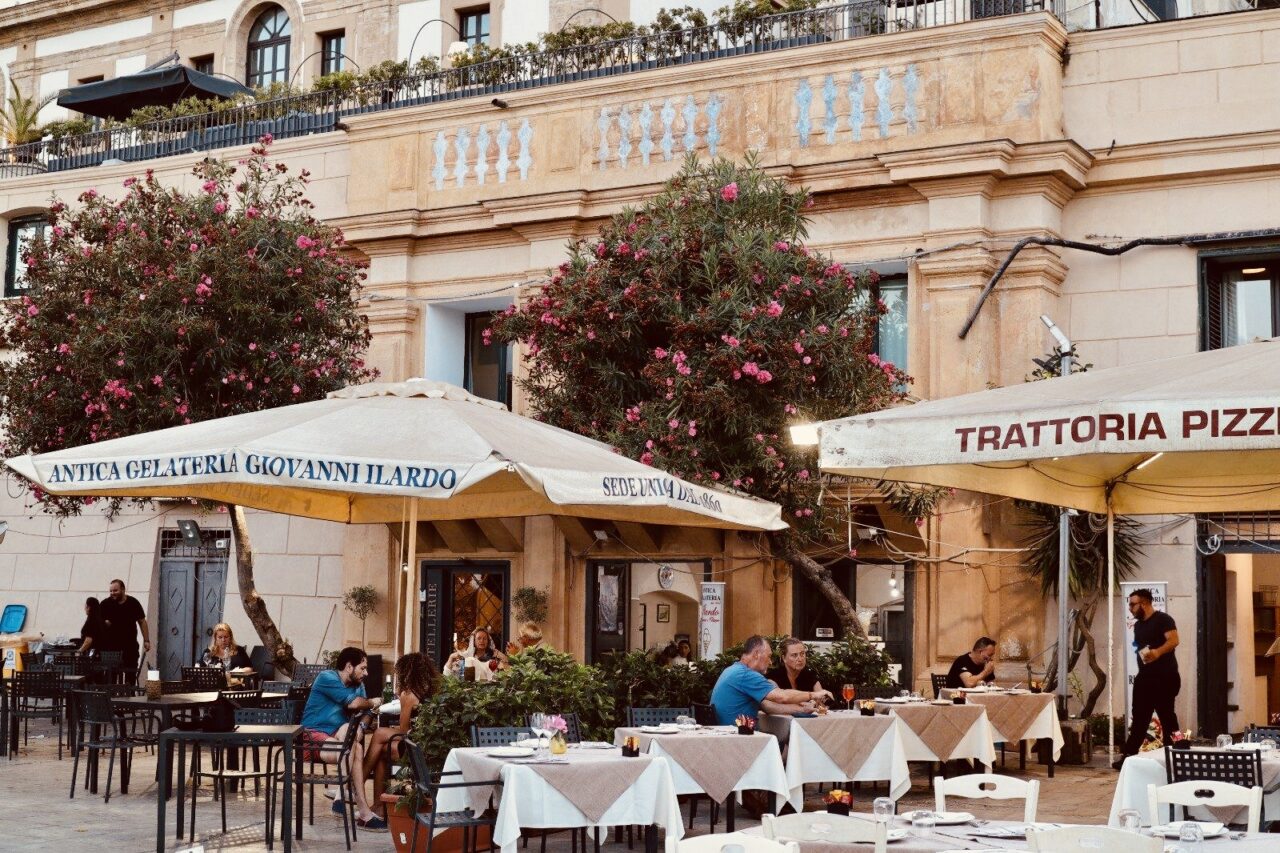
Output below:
[0,722,1116,853]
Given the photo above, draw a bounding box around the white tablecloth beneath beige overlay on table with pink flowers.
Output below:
[439,749,684,853]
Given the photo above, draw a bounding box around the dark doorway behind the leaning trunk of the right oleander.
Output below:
[791,558,915,684]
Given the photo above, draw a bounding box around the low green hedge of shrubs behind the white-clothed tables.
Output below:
[412,637,888,767]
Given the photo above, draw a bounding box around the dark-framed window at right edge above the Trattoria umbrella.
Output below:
[1201,255,1280,350]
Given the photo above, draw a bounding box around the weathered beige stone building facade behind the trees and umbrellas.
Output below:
[0,0,1280,730]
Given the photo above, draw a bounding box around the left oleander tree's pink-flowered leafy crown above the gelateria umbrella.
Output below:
[0,137,375,514]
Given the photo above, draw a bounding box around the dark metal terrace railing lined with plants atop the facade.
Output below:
[0,0,1065,178]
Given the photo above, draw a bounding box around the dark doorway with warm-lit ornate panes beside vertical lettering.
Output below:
[420,560,511,665]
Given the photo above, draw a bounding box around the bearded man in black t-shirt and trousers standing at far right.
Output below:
[1111,589,1183,770]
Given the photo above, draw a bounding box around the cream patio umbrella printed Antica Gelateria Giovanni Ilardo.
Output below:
[6,379,786,648]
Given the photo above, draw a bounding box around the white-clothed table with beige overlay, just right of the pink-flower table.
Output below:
[613,726,790,833]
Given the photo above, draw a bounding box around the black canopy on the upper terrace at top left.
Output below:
[58,65,253,119]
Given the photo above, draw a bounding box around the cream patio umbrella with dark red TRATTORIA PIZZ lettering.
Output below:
[818,338,1280,745]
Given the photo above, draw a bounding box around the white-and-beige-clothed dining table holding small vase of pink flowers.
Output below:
[436,743,684,853]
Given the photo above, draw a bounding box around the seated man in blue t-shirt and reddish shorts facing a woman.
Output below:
[302,646,387,833]
